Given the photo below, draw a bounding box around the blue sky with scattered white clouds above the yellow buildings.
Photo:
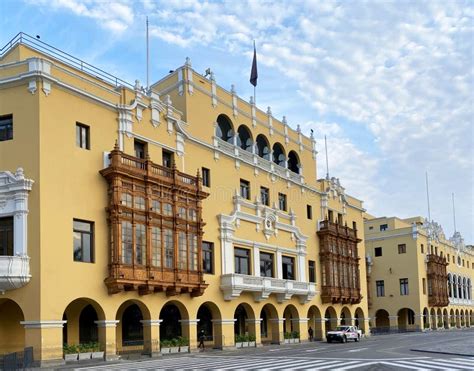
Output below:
[0,0,474,244]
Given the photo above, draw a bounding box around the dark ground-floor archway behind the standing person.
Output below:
[197,302,224,348]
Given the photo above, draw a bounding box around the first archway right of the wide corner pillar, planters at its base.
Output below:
[63,298,105,345]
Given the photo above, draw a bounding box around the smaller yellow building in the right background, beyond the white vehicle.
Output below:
[365,217,474,332]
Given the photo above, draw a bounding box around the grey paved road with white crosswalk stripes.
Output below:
[72,330,474,371]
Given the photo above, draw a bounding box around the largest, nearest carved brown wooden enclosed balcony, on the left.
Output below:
[100,147,208,296]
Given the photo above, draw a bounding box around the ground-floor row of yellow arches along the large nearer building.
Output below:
[0,296,369,361]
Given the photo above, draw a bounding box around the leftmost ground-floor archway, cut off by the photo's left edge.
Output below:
[0,299,25,354]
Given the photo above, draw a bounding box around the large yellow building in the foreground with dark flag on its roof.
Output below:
[0,34,368,364]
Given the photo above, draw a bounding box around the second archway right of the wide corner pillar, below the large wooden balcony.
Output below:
[115,300,151,353]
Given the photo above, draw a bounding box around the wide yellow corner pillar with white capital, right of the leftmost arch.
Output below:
[20,320,67,367]
